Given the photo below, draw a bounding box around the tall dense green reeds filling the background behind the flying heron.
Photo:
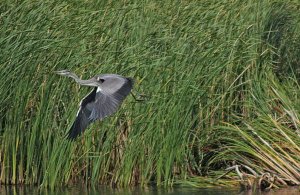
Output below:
[0,0,300,187]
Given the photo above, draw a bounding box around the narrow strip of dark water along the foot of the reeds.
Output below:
[0,185,300,195]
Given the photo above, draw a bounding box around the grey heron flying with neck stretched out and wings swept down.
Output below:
[56,70,134,140]
